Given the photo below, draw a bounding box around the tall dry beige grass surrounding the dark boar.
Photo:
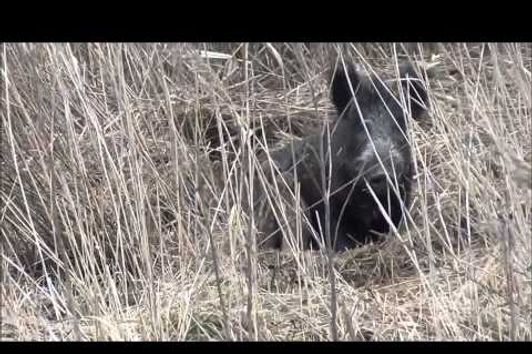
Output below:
[0,43,532,340]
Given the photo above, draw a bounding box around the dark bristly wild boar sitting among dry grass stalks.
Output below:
[255,63,427,251]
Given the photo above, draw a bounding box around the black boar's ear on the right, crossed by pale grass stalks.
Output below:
[399,62,429,119]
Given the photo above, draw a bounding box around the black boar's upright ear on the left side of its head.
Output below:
[331,64,361,114]
